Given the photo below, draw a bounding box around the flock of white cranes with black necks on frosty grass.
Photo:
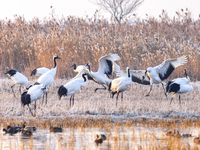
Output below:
[6,54,193,116]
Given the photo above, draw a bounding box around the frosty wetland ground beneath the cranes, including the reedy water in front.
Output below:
[0,79,200,150]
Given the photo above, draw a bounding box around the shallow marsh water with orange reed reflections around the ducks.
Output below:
[0,124,200,150]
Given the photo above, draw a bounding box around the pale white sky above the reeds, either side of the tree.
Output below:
[0,0,200,20]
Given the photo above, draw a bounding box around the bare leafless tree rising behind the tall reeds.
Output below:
[90,0,144,24]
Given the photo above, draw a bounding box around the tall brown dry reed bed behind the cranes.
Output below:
[0,10,200,81]
